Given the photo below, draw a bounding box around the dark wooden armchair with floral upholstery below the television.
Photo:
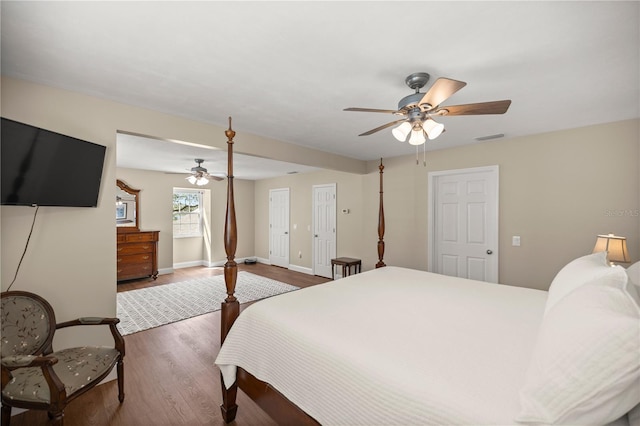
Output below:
[0,291,124,426]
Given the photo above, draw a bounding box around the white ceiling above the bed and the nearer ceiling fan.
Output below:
[1,1,640,175]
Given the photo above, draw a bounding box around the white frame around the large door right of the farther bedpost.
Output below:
[427,165,500,282]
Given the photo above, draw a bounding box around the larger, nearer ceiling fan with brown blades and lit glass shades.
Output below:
[344,72,511,146]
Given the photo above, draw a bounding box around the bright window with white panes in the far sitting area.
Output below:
[173,189,202,238]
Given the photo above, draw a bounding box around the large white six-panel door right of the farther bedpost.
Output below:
[429,166,498,282]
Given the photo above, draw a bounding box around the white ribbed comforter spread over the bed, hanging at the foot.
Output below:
[216,267,547,425]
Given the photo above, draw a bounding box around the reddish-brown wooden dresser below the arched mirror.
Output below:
[116,231,160,281]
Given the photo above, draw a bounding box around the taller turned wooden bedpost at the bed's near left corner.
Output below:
[220,117,240,423]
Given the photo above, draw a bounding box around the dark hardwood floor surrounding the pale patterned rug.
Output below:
[11,264,330,426]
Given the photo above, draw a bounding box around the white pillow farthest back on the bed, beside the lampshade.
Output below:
[544,251,611,315]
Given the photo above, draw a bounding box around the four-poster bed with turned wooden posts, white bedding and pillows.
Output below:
[216,119,640,425]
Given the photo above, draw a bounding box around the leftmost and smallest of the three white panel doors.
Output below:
[269,188,289,268]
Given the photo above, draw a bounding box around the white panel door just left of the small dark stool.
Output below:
[313,184,336,278]
